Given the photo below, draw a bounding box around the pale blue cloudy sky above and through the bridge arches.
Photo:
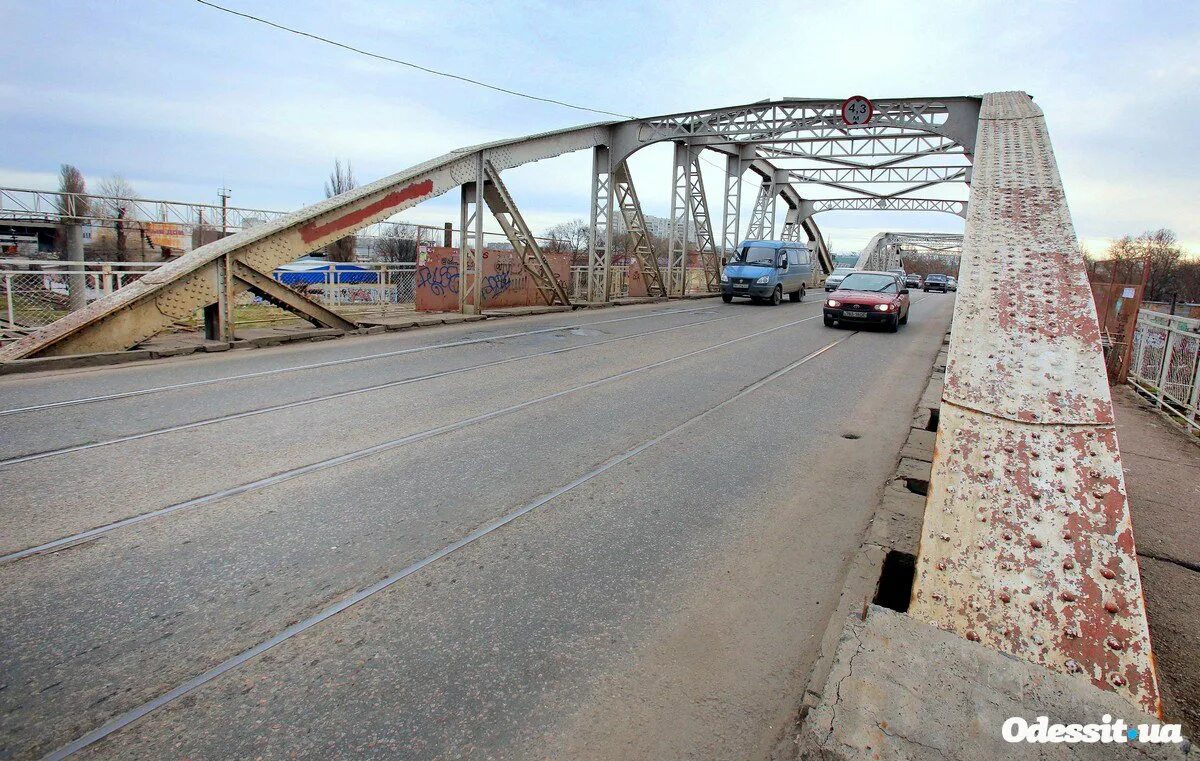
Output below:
[0,0,1200,253]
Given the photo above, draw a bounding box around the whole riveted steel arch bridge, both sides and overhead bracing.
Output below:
[0,92,1158,712]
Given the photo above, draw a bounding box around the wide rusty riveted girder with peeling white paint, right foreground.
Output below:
[910,92,1158,712]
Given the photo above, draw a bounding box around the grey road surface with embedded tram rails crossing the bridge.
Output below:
[0,294,954,759]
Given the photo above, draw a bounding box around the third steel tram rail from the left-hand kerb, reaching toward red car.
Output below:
[0,307,821,564]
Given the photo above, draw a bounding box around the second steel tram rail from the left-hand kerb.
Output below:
[0,304,758,465]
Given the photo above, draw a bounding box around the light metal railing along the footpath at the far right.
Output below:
[1129,310,1200,431]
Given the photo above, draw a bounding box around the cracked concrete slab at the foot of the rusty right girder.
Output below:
[798,605,1195,761]
